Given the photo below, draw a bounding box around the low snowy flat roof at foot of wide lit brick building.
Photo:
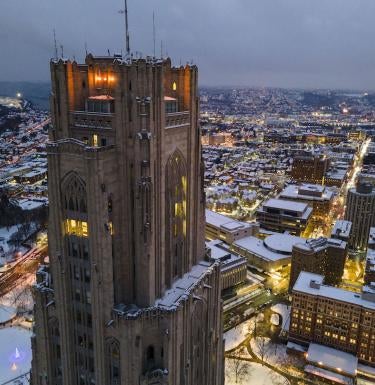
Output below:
[306,343,358,376]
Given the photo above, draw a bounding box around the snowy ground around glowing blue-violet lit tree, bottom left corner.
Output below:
[0,327,31,384]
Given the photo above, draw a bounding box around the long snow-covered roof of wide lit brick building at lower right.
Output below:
[293,271,375,310]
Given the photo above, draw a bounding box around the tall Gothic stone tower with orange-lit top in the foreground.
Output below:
[32,55,224,385]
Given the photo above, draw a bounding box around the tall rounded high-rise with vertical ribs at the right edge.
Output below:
[345,182,375,250]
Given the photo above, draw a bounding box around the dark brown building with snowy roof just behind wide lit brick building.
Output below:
[289,237,347,290]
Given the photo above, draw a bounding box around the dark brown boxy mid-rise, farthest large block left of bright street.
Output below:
[291,154,329,184]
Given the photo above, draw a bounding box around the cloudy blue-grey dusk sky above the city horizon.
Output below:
[0,0,375,90]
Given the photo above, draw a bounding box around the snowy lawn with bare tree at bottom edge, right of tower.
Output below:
[225,358,289,385]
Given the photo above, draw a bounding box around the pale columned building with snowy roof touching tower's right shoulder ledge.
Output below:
[206,239,247,290]
